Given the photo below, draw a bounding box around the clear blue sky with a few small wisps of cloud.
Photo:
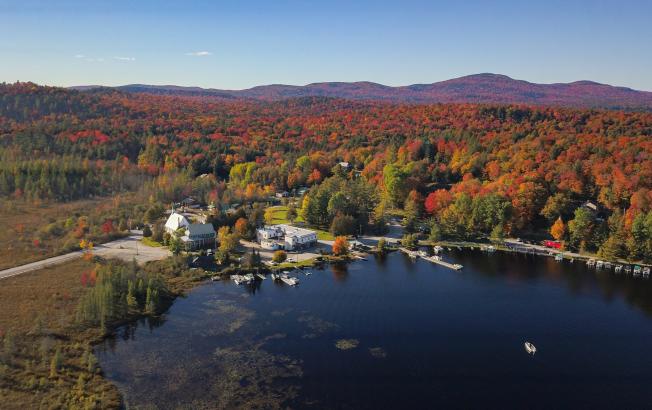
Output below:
[0,0,652,91]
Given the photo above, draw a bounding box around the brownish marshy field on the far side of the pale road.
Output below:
[0,198,132,269]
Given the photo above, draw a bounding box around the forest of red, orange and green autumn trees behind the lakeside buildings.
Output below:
[0,83,652,260]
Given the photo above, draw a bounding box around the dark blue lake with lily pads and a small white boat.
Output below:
[97,251,652,409]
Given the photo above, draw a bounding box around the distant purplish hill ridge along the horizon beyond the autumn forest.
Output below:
[73,74,652,110]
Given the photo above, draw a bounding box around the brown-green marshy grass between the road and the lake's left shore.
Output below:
[0,259,120,409]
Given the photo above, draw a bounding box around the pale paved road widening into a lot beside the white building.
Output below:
[0,232,172,279]
